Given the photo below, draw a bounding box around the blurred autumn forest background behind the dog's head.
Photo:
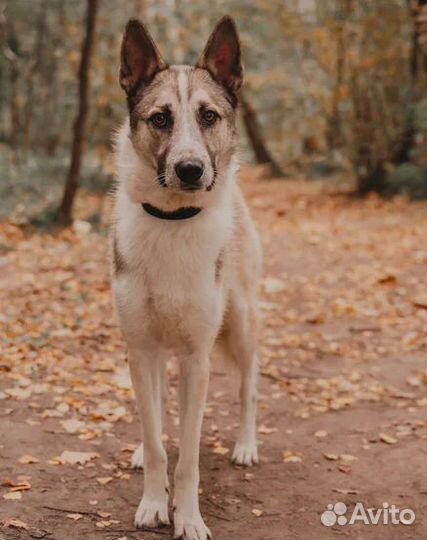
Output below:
[0,0,427,222]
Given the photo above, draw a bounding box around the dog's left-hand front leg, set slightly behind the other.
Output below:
[129,344,169,527]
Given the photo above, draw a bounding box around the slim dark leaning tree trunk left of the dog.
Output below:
[57,0,98,225]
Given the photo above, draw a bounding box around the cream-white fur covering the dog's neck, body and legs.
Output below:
[113,95,260,540]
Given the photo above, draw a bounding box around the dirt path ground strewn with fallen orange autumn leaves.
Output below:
[0,171,427,540]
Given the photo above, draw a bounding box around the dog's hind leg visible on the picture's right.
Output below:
[223,295,258,466]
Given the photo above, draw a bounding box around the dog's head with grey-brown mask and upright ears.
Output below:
[120,17,243,193]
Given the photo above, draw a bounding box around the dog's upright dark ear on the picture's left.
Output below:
[119,19,167,94]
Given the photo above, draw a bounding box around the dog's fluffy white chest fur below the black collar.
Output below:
[114,186,233,346]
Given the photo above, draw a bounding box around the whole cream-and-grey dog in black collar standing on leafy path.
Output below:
[111,17,261,540]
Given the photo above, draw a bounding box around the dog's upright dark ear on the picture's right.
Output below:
[197,16,243,92]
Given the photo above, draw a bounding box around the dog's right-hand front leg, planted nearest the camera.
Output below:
[174,355,211,540]
